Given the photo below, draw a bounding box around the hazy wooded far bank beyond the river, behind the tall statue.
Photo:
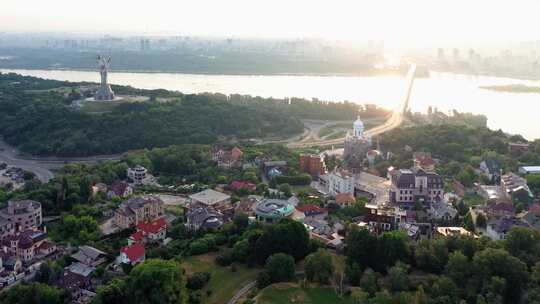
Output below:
[0,48,403,75]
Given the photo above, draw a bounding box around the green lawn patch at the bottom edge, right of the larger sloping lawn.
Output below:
[256,283,353,304]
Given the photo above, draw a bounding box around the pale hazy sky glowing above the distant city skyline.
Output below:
[4,0,540,42]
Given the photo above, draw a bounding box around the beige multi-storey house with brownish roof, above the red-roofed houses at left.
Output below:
[114,195,165,229]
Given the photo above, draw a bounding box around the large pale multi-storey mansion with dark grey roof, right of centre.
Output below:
[389,169,444,209]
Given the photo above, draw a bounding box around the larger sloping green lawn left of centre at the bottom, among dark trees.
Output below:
[182,252,259,304]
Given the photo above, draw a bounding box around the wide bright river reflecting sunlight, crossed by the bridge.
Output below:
[0,69,540,140]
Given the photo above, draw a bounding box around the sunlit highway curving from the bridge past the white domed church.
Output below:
[287,64,416,148]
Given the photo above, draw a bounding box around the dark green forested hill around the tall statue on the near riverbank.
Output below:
[0,74,387,156]
